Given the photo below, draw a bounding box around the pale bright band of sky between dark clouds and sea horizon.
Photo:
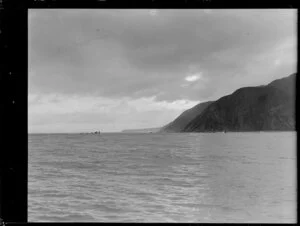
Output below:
[28,94,198,132]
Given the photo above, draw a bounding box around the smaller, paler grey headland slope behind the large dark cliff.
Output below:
[160,101,212,132]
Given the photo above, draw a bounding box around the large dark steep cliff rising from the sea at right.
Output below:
[181,74,296,132]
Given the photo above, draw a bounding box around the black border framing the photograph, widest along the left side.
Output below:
[0,0,299,225]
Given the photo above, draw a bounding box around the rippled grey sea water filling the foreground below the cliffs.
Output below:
[28,132,297,223]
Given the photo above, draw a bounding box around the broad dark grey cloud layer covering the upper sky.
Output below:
[29,9,296,101]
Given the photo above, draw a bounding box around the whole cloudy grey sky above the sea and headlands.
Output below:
[28,9,297,133]
